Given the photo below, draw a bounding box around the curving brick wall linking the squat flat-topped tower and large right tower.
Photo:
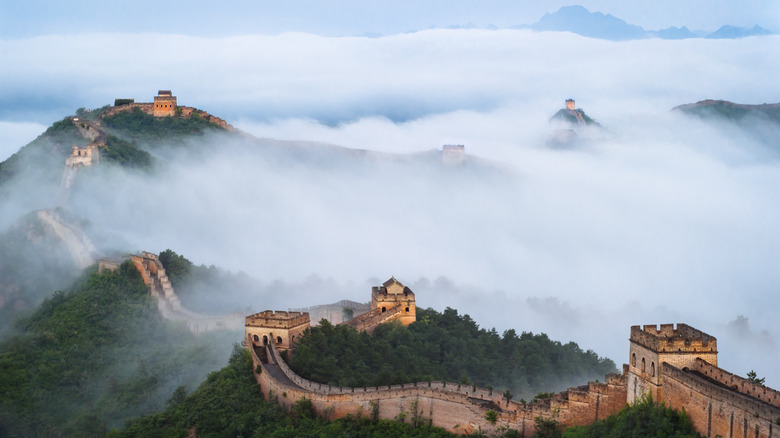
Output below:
[245,334,626,437]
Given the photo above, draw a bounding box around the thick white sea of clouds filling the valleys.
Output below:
[0,30,780,387]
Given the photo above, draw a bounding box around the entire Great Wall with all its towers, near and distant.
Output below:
[39,90,780,438]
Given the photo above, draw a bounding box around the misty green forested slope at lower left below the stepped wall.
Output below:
[0,263,235,437]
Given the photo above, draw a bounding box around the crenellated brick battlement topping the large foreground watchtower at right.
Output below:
[630,323,718,353]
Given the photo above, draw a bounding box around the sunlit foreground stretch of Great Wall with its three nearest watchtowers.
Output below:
[244,279,780,438]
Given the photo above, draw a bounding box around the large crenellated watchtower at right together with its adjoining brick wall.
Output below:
[624,324,780,438]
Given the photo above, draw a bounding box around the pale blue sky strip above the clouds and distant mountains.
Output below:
[0,0,780,38]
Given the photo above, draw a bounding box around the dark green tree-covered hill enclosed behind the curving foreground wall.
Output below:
[291,308,617,399]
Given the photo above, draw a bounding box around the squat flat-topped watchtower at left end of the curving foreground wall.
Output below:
[244,310,309,350]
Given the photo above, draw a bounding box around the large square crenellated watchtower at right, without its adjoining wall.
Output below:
[627,323,718,403]
